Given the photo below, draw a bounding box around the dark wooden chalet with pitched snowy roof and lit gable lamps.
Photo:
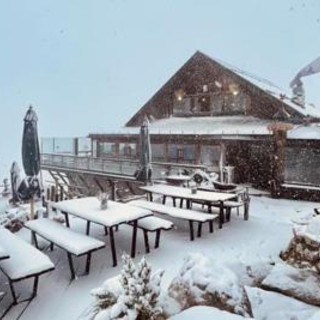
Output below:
[42,51,320,199]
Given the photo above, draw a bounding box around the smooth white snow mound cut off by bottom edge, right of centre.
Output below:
[170,306,251,320]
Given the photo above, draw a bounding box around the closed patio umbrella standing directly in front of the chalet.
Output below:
[140,119,152,183]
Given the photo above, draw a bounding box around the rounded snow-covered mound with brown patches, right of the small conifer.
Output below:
[169,254,252,316]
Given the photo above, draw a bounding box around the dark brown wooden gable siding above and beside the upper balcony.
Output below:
[126,52,303,127]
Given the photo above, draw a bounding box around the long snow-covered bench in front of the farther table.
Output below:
[129,200,219,241]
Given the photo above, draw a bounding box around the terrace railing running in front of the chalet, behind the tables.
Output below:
[41,153,207,179]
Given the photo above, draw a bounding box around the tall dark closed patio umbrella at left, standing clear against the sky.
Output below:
[22,106,40,218]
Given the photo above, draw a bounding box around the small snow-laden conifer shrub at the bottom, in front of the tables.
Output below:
[91,254,163,320]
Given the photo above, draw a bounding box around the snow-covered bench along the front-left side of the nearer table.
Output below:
[25,218,105,280]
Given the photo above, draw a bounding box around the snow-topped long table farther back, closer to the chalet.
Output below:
[140,184,236,228]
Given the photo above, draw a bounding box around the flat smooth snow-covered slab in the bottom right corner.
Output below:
[246,287,319,320]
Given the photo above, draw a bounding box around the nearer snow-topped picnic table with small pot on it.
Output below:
[51,197,153,266]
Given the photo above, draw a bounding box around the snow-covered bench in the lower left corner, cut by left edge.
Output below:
[0,228,54,305]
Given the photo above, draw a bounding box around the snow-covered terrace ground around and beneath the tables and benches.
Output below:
[0,191,319,320]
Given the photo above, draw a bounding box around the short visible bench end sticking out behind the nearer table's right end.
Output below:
[132,216,173,253]
